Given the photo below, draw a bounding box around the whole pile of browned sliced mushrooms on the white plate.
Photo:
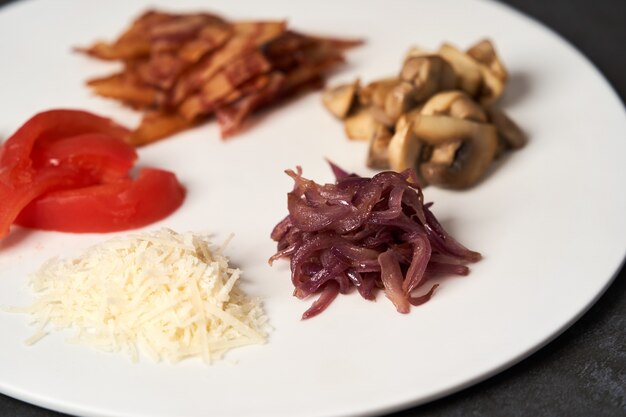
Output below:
[323,40,526,189]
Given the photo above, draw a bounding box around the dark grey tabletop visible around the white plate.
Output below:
[0,0,626,417]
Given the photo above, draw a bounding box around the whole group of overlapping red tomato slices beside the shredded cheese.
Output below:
[0,110,185,238]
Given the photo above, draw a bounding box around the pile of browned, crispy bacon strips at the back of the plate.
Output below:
[79,11,361,146]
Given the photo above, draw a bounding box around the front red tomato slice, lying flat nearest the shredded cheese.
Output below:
[15,168,185,233]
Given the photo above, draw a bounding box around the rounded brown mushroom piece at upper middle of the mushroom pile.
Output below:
[400,55,457,102]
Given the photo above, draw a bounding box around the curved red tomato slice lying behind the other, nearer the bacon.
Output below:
[0,110,137,238]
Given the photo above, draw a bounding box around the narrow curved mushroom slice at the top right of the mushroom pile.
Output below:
[467,40,508,106]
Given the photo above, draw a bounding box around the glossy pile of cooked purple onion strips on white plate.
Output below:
[269,164,481,319]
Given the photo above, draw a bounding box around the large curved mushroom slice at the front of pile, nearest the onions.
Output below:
[412,116,498,189]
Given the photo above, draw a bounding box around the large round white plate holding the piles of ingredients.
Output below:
[0,0,626,417]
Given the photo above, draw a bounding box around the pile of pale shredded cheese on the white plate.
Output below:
[15,229,268,363]
